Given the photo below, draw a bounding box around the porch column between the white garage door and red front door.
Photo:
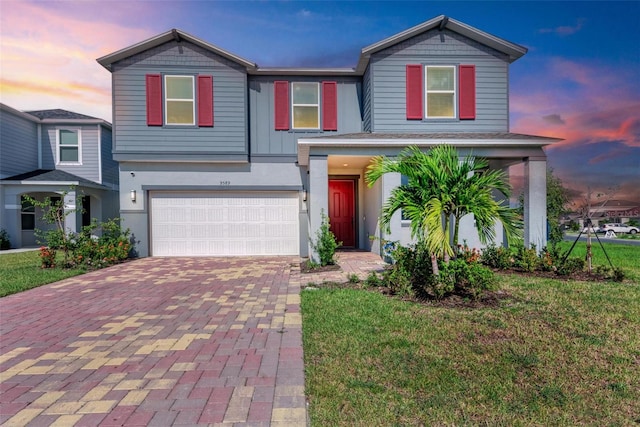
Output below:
[307,156,329,262]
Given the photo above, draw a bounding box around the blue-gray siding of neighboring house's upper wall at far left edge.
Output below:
[0,109,38,179]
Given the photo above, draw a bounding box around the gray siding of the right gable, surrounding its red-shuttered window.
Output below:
[370,30,509,132]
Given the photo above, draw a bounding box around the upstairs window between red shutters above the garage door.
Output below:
[164,76,196,126]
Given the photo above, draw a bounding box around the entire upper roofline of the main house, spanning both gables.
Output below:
[97,15,527,76]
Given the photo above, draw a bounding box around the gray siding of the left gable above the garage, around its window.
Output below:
[112,41,248,160]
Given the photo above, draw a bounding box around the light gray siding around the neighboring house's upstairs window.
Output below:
[42,124,100,182]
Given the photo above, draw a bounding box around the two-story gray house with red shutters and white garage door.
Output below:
[98,16,558,256]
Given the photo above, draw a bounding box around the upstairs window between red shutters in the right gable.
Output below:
[424,66,457,118]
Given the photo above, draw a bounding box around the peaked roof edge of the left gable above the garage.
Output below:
[97,28,258,71]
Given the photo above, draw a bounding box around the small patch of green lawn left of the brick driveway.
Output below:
[0,251,86,297]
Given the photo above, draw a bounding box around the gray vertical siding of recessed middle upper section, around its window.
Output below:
[249,76,362,155]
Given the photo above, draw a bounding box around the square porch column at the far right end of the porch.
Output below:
[524,157,547,249]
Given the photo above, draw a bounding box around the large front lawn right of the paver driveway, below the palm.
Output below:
[302,245,640,426]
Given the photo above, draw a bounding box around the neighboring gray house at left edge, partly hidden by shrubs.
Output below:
[0,104,119,248]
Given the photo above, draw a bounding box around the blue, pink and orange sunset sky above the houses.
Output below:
[0,0,640,204]
